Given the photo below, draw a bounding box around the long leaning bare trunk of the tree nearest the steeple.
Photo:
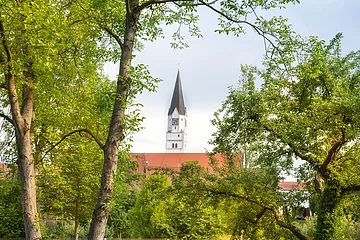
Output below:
[88,4,139,240]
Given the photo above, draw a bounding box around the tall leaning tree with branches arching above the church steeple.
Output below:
[89,0,299,239]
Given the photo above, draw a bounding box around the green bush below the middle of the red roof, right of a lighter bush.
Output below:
[170,162,227,239]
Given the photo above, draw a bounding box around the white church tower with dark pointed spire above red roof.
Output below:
[166,70,187,153]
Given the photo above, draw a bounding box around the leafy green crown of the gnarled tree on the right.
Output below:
[214,33,358,178]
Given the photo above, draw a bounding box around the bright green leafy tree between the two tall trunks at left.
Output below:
[34,55,114,239]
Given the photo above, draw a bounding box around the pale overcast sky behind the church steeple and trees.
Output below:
[105,0,360,152]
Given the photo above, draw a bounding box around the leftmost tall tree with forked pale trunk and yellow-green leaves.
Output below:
[0,0,106,239]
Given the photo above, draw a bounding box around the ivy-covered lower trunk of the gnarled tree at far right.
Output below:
[315,183,343,240]
